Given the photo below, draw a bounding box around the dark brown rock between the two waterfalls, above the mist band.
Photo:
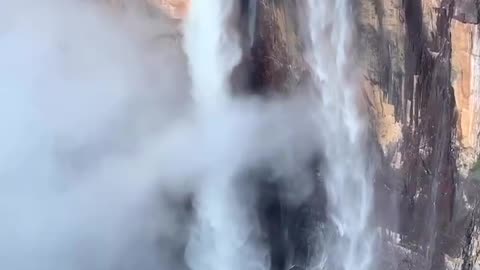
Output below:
[246,0,306,91]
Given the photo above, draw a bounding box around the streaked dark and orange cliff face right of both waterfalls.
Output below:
[358,0,480,269]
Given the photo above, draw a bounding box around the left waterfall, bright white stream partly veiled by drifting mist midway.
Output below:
[184,0,264,270]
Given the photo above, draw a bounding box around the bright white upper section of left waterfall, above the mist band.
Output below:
[184,0,241,112]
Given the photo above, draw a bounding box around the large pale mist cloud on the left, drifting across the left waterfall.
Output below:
[0,0,324,270]
